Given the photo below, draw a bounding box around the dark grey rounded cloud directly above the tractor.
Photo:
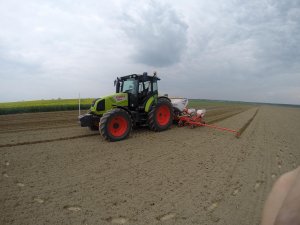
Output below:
[123,1,188,67]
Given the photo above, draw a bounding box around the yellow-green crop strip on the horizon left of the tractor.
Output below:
[0,98,93,115]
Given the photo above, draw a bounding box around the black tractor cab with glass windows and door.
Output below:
[115,72,160,110]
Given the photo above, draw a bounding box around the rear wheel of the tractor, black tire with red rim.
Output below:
[148,98,174,131]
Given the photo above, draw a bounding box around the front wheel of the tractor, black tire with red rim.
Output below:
[99,108,132,142]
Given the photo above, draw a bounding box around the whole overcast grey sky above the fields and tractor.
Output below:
[0,0,300,104]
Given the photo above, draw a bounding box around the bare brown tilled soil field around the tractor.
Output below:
[0,106,300,225]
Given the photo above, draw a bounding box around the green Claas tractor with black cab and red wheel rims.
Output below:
[79,73,173,141]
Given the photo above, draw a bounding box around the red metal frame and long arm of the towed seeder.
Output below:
[176,114,240,137]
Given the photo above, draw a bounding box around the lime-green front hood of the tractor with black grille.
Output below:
[90,93,128,116]
